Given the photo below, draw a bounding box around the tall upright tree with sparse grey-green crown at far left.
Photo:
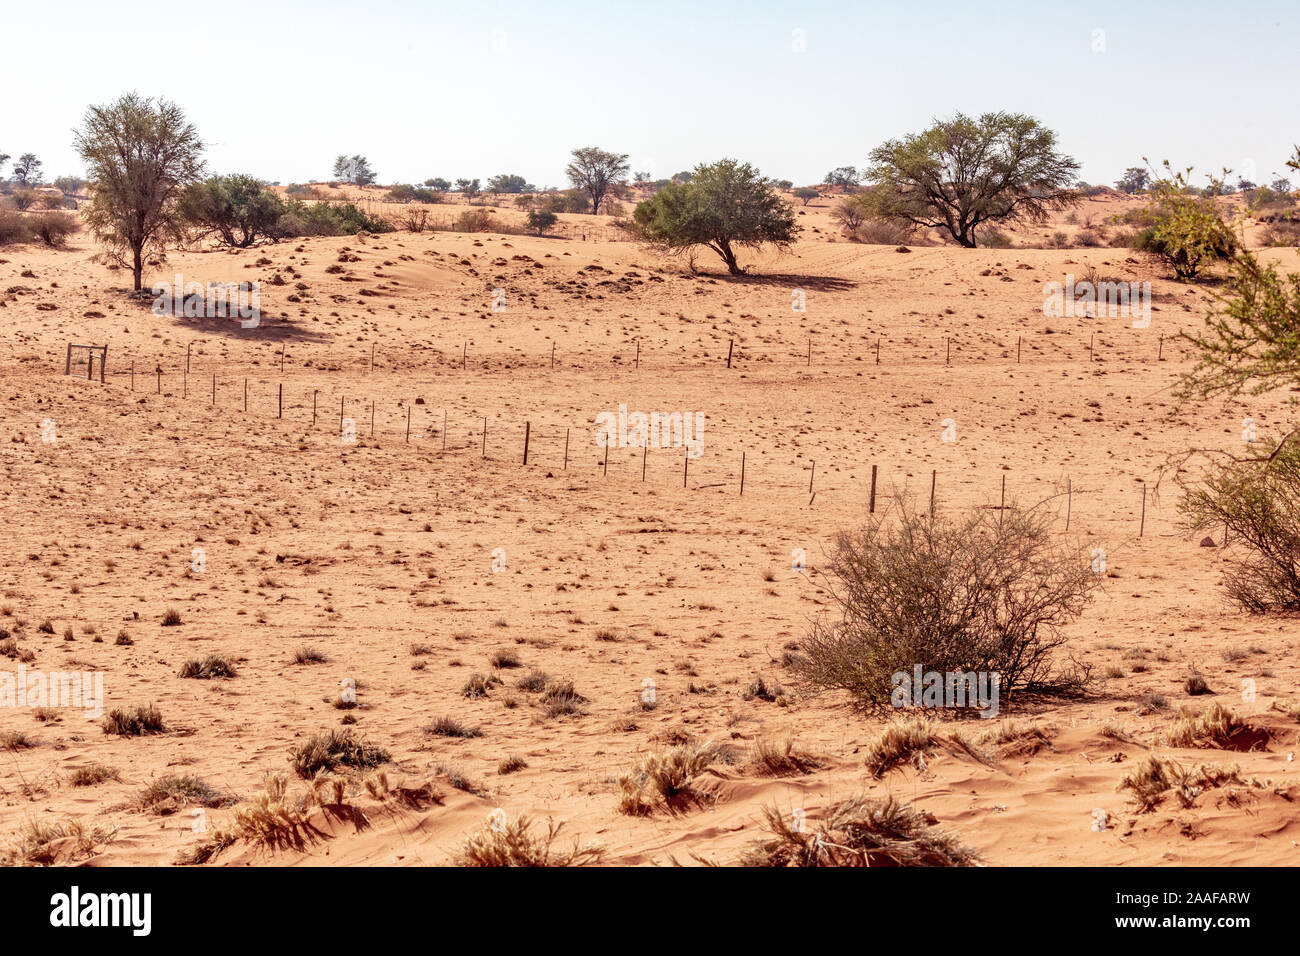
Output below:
[74,92,203,291]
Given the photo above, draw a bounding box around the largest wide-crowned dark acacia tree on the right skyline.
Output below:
[866,112,1079,248]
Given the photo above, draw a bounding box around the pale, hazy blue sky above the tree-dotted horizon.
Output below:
[0,0,1300,186]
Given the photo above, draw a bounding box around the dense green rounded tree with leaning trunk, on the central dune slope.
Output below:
[633,159,800,276]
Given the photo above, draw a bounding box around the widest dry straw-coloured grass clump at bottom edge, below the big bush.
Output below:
[738,796,979,866]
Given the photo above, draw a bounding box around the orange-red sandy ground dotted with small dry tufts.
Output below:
[0,188,1300,865]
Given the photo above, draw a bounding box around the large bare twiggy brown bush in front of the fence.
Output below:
[790,499,1099,709]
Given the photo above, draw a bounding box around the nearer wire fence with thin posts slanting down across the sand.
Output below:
[50,340,1157,537]
